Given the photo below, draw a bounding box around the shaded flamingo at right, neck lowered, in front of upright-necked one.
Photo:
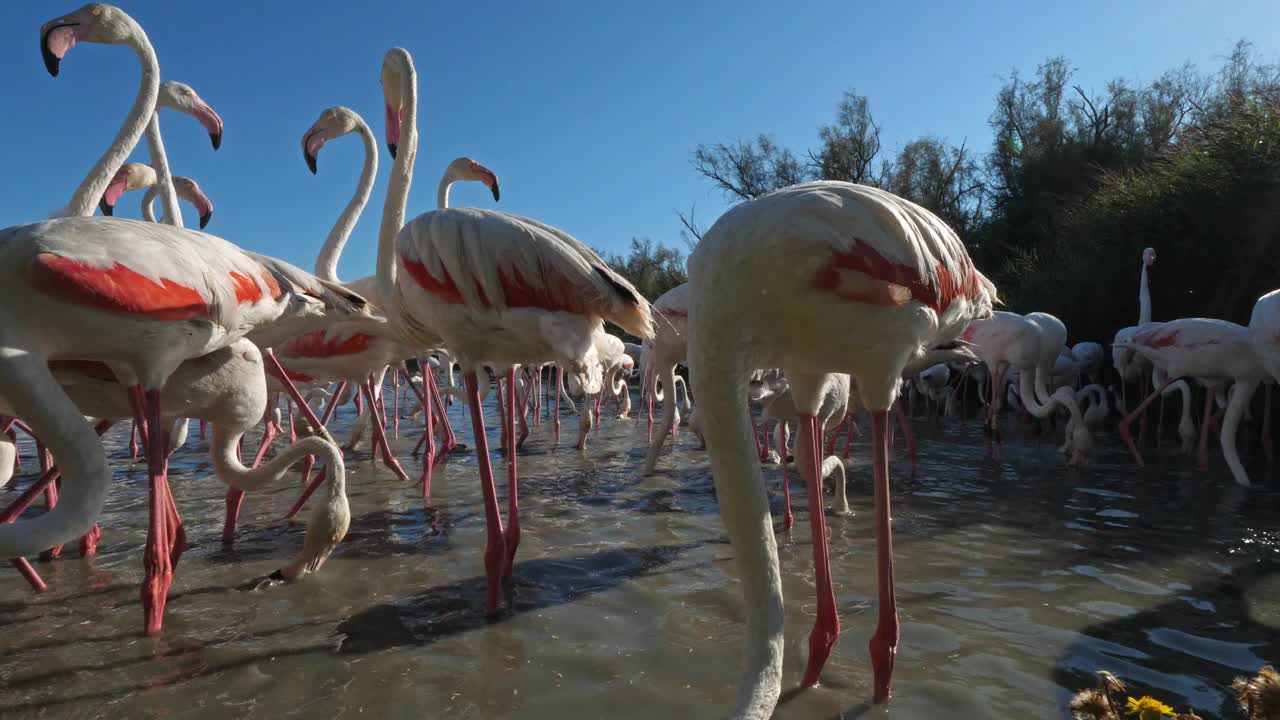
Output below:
[1120,316,1267,487]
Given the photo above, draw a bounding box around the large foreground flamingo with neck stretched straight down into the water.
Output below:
[689,182,996,719]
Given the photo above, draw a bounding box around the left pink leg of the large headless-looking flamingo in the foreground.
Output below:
[796,415,840,688]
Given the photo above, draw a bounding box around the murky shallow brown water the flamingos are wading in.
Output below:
[0,386,1280,720]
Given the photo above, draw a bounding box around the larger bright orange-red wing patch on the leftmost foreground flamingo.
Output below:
[29,252,209,320]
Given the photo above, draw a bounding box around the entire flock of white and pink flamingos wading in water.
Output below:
[0,3,1280,719]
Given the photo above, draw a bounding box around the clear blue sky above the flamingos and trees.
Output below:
[0,0,1280,279]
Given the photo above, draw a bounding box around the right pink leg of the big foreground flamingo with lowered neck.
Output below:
[869,410,899,703]
